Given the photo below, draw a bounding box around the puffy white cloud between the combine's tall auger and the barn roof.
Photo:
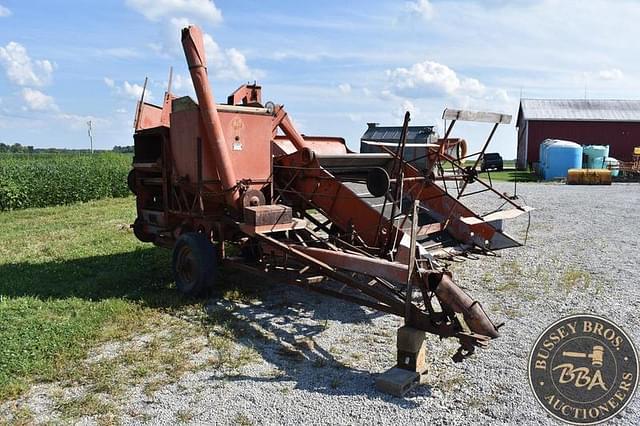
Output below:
[387,61,484,97]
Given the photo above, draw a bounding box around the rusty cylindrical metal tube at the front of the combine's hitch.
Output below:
[427,273,500,339]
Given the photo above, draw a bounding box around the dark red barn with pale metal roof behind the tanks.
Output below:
[516,99,640,169]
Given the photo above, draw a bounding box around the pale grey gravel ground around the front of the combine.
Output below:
[5,184,640,425]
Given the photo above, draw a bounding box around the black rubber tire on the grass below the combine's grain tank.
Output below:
[171,232,218,297]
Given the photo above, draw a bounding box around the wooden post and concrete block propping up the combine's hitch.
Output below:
[376,325,427,397]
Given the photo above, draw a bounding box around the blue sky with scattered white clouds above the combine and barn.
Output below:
[0,0,640,158]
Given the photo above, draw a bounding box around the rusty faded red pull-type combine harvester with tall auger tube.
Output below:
[129,27,530,393]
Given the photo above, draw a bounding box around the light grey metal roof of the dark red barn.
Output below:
[518,99,640,123]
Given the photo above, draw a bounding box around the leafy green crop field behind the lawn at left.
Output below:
[0,153,131,211]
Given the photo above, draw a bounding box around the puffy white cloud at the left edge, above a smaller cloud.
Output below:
[0,41,54,86]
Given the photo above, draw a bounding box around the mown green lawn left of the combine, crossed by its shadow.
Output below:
[0,198,180,401]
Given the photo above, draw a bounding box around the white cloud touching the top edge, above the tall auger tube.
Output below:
[126,0,222,24]
